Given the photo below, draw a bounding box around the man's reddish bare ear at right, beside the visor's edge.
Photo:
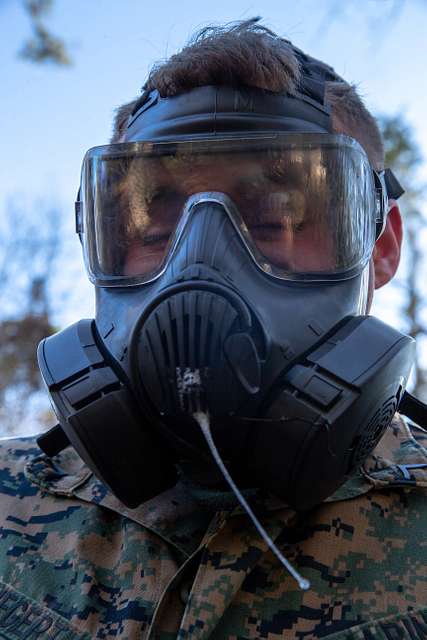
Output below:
[372,200,402,289]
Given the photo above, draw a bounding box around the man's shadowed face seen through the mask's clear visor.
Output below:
[121,153,335,276]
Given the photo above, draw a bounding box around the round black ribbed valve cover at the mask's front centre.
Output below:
[136,282,263,415]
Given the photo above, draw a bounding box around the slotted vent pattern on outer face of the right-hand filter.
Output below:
[347,394,399,474]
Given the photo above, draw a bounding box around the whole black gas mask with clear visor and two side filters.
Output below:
[38,87,414,509]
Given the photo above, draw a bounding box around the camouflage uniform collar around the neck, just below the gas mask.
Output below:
[26,414,427,555]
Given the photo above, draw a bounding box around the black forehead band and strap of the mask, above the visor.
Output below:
[126,41,344,140]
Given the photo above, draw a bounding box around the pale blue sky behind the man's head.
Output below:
[0,0,427,326]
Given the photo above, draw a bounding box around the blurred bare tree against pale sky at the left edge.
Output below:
[0,201,60,435]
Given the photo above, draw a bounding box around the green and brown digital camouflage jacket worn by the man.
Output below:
[0,418,427,640]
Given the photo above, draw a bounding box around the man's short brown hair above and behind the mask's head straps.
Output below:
[111,18,384,169]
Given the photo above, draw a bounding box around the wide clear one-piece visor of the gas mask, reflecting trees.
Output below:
[82,134,376,285]
